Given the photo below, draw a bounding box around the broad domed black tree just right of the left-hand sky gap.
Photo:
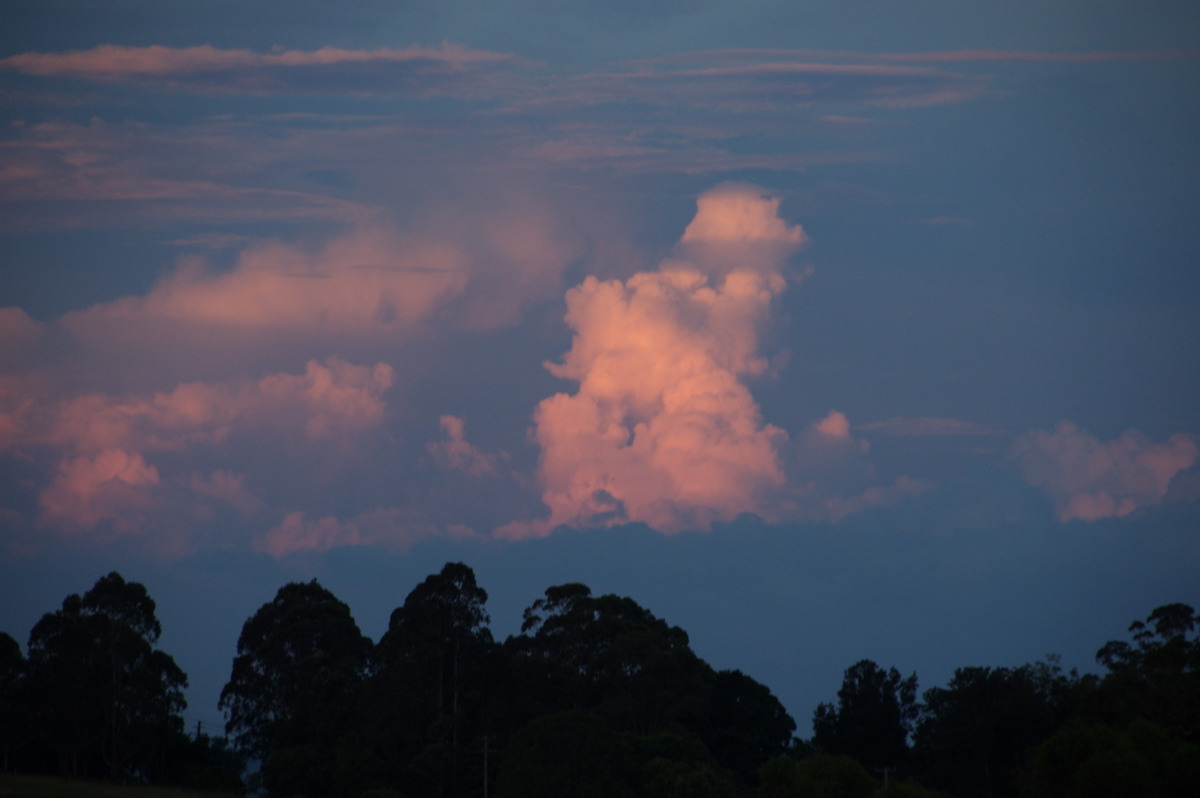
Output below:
[220,580,371,796]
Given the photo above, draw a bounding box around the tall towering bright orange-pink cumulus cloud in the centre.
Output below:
[497,186,805,538]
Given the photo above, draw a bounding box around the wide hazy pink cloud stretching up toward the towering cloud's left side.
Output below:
[62,205,582,349]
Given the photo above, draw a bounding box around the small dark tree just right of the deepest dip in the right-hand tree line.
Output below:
[812,660,918,772]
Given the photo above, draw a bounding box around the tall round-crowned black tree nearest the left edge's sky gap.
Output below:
[26,572,187,779]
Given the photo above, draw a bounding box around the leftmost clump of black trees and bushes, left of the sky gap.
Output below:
[0,572,244,791]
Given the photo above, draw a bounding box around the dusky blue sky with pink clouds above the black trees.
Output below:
[0,0,1200,736]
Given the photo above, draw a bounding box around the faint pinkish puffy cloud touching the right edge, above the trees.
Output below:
[1013,421,1198,522]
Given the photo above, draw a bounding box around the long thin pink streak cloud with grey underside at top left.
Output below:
[0,42,515,94]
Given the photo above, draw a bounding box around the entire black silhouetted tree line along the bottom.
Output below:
[0,563,1200,798]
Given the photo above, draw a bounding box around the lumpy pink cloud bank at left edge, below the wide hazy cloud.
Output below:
[0,358,394,544]
